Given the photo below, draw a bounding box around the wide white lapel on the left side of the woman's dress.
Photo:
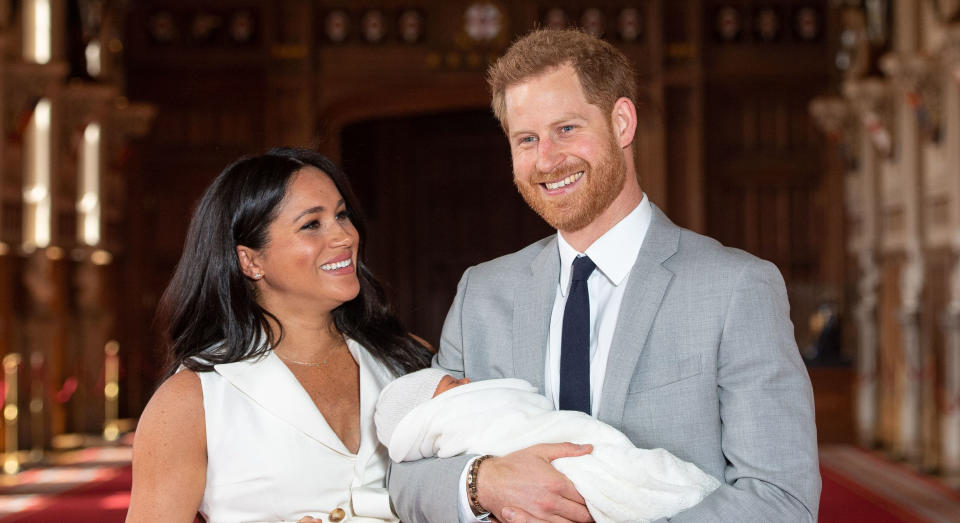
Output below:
[214,351,354,456]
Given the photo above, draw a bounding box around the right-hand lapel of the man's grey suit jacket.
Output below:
[597,204,680,429]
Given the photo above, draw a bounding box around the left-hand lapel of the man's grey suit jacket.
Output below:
[513,236,560,394]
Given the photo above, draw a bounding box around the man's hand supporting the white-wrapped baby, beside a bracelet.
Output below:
[477,443,593,523]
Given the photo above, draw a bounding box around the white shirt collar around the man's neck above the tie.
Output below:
[557,194,653,296]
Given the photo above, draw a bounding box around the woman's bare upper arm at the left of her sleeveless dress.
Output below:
[127,370,207,523]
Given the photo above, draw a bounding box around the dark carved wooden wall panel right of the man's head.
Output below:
[705,85,834,281]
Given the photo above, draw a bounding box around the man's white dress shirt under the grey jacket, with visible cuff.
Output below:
[459,194,653,523]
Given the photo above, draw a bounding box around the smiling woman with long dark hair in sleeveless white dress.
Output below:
[127,149,429,522]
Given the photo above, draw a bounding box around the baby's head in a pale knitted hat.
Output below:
[373,369,470,445]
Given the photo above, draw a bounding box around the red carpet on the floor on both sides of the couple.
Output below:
[0,446,960,523]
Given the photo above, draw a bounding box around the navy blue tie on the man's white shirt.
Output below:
[560,256,597,414]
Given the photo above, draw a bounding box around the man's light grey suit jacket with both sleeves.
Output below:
[388,208,820,523]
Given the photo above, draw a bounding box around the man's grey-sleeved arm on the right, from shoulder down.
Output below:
[671,261,820,522]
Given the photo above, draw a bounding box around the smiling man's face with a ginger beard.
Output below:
[504,65,627,232]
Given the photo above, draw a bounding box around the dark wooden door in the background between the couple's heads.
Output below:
[342,109,553,345]
